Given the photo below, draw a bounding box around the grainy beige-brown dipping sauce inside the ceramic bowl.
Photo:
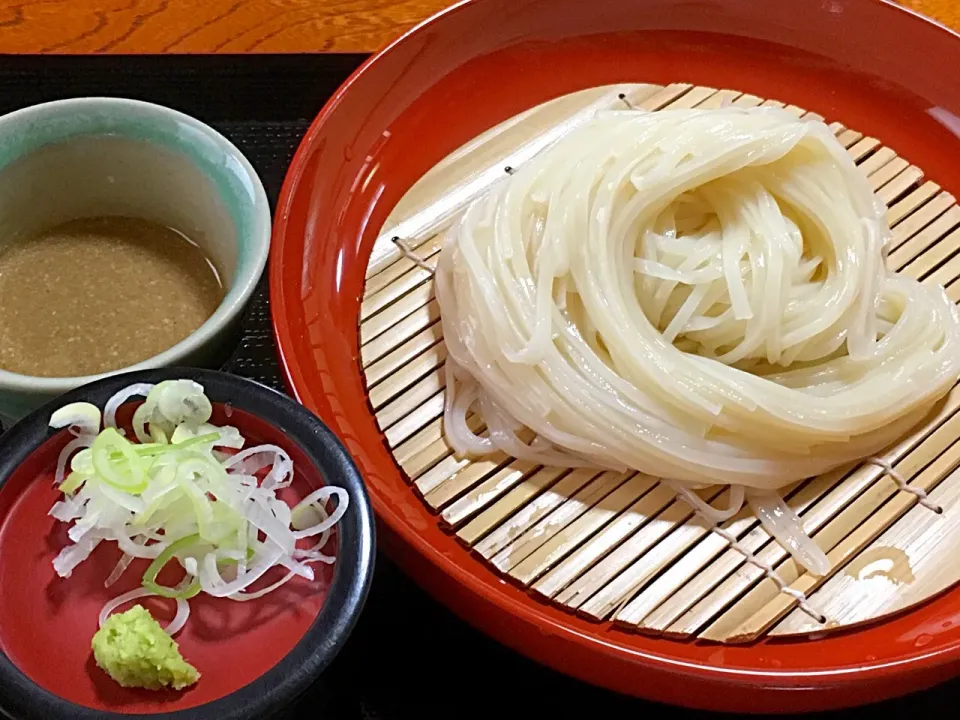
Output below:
[0,217,224,377]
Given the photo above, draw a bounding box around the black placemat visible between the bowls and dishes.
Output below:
[0,55,960,720]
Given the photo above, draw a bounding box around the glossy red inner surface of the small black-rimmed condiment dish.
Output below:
[0,405,335,714]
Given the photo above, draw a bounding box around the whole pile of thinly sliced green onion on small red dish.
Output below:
[50,380,346,625]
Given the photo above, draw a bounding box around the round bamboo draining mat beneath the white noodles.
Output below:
[360,84,960,642]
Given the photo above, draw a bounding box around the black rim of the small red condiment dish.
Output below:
[0,368,375,720]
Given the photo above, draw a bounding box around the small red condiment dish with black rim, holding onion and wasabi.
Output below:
[0,369,374,720]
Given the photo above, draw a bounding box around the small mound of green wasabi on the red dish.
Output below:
[92,605,200,690]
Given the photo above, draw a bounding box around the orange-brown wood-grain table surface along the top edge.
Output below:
[0,0,960,53]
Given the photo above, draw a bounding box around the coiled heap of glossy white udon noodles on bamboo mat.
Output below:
[435,108,960,574]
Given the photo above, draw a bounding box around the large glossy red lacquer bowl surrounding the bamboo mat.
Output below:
[271,0,960,711]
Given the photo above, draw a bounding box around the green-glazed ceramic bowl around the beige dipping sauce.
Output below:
[0,98,270,424]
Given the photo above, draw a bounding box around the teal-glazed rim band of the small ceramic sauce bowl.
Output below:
[0,97,271,400]
